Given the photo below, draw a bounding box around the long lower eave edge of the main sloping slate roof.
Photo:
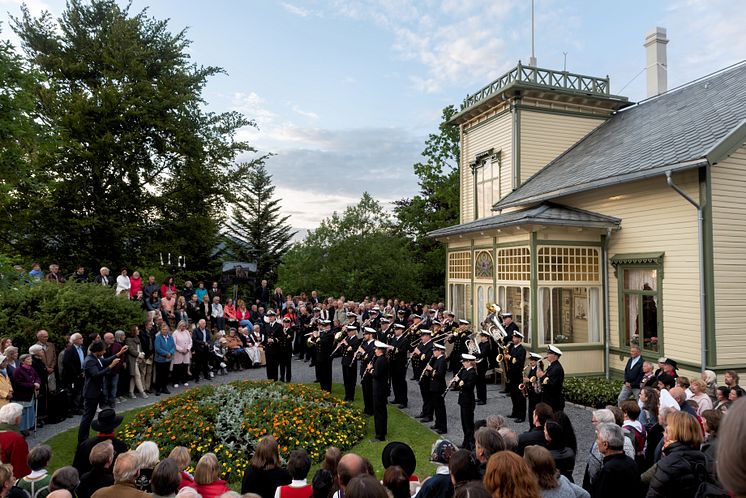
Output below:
[492,158,708,211]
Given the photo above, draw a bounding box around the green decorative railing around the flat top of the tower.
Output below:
[461,61,610,111]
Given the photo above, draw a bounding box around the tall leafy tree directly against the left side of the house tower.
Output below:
[394,106,460,301]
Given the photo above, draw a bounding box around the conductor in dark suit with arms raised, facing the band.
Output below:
[78,342,128,444]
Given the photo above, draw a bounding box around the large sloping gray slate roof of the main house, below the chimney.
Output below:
[493,62,746,210]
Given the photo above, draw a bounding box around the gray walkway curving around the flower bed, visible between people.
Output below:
[33,360,595,482]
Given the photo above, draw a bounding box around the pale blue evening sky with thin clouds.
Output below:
[0,0,746,231]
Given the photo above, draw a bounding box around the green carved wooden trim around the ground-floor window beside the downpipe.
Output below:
[609,252,665,356]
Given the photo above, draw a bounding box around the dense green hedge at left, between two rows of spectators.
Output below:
[0,282,145,352]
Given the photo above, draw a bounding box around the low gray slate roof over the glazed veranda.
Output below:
[427,202,622,237]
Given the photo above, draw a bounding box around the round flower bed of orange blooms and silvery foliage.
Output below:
[119,381,366,482]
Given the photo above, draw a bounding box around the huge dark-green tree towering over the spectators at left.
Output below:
[5,0,252,267]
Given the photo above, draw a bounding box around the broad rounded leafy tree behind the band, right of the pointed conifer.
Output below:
[279,192,420,299]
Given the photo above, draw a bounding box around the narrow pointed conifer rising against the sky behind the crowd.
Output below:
[226,157,296,281]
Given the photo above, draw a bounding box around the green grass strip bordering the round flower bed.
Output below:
[47,384,438,479]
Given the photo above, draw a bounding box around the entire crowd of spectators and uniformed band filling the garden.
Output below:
[5,268,744,498]
